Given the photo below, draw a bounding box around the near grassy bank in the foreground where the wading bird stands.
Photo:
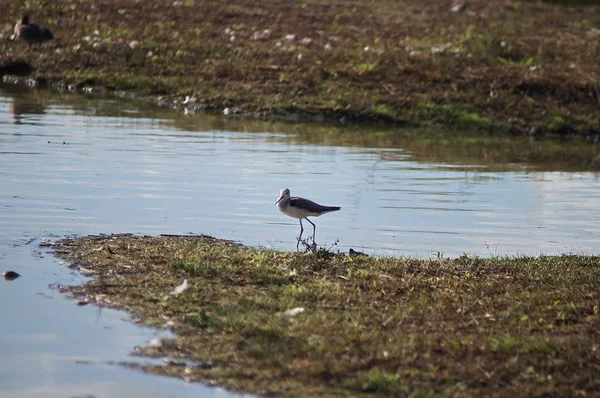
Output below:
[53,236,600,397]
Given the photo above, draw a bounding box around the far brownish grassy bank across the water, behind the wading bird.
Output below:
[0,0,600,139]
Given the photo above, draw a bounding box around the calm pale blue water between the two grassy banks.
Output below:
[0,86,600,397]
